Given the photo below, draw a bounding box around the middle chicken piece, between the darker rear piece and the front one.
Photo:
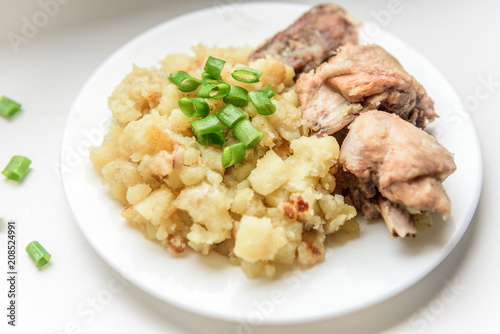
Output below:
[296,43,437,134]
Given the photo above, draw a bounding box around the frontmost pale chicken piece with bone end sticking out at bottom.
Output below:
[339,110,456,237]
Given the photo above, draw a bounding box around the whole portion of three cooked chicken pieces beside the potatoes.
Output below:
[250,4,456,237]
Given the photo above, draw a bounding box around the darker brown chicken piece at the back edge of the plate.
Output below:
[249,4,358,78]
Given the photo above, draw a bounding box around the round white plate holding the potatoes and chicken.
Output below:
[61,3,482,324]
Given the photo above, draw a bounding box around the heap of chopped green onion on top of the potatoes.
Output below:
[168,56,276,168]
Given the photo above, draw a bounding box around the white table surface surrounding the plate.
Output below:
[0,0,500,334]
